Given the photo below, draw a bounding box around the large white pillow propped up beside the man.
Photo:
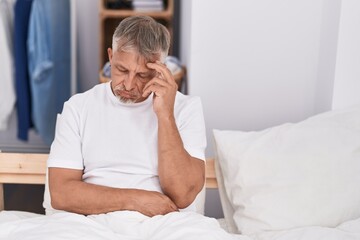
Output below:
[214,106,360,235]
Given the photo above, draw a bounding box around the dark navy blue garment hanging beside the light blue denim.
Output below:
[14,0,32,141]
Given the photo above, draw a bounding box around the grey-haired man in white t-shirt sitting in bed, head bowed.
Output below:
[48,16,236,237]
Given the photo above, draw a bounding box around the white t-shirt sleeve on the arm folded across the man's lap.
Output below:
[48,99,84,170]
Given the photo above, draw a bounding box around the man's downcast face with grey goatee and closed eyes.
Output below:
[108,48,157,103]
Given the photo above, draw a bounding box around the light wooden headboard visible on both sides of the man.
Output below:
[0,152,217,211]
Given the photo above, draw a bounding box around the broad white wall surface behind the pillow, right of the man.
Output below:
[181,0,341,217]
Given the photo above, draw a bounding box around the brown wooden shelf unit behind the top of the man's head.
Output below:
[99,0,174,69]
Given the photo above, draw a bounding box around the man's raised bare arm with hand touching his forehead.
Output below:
[143,62,205,208]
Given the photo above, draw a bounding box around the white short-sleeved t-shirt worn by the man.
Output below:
[44,82,206,212]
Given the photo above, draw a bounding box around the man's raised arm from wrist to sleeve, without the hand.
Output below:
[158,114,205,208]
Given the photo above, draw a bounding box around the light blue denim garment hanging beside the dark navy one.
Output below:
[28,0,71,145]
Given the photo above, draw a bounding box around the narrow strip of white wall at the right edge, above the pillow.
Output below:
[332,0,360,109]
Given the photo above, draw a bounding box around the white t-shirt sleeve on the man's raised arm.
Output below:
[178,97,206,160]
